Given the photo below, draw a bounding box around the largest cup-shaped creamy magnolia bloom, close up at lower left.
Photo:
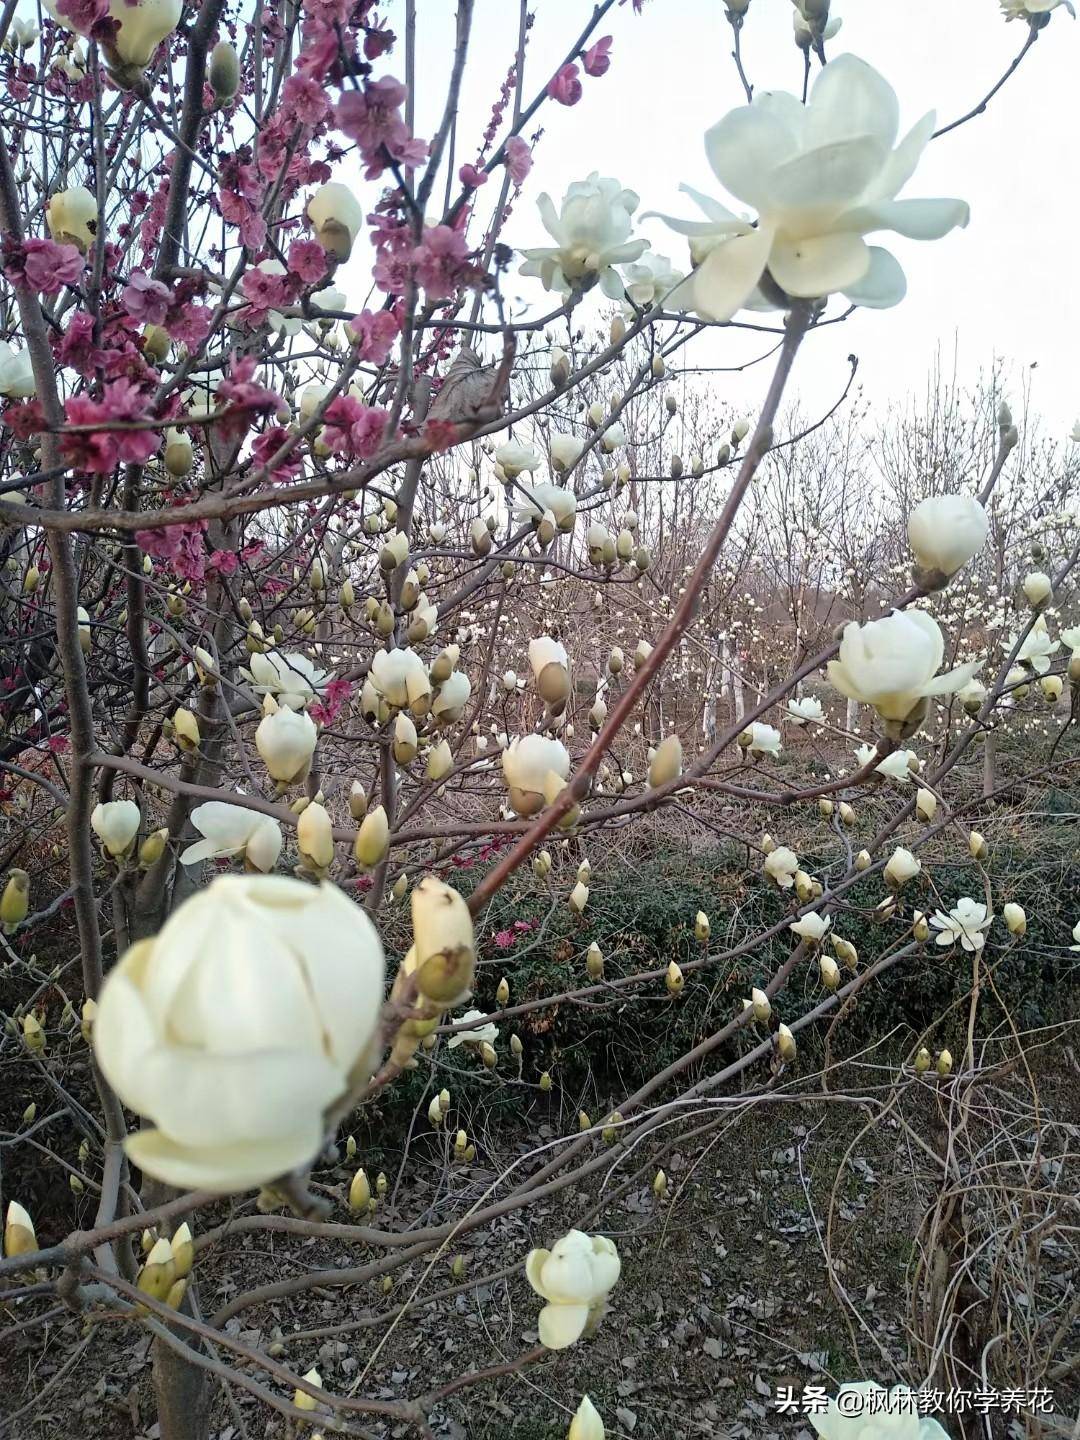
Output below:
[94,876,383,1194]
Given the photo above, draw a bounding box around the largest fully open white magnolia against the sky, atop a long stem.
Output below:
[662,55,968,321]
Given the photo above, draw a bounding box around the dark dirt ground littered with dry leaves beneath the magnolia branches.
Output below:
[8,1074,1080,1440]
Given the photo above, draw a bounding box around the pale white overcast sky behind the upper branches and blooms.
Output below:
[371,0,1080,433]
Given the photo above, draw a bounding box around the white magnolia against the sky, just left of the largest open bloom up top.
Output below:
[521,170,648,300]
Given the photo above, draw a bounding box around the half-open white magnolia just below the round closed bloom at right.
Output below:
[827,611,982,740]
